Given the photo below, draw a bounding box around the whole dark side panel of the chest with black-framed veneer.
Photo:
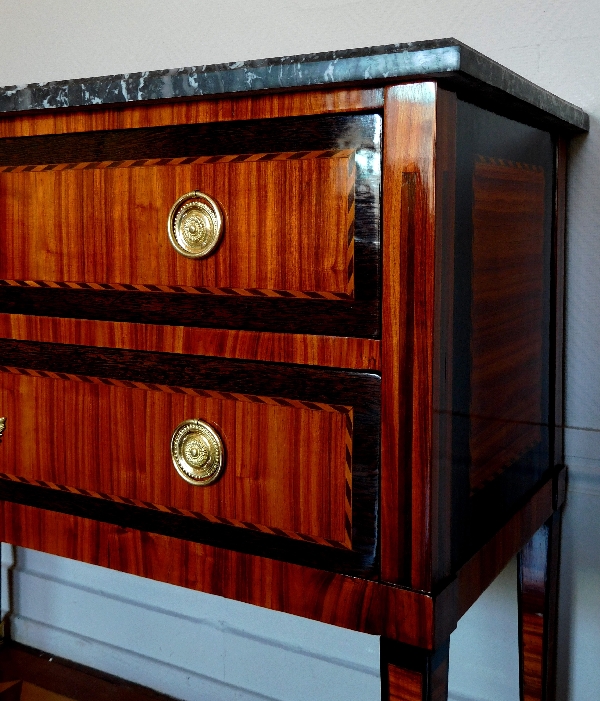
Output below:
[449,100,562,567]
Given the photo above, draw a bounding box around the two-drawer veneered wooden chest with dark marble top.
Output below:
[0,40,587,701]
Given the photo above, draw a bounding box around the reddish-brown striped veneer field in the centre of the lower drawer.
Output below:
[0,370,352,547]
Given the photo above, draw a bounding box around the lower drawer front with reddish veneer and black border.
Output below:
[0,341,379,573]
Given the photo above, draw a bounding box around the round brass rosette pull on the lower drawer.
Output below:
[171,419,225,487]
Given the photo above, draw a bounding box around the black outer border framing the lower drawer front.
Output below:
[0,340,381,576]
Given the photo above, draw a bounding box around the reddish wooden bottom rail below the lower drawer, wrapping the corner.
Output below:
[0,434,555,648]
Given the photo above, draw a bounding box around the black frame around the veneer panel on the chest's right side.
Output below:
[452,100,555,569]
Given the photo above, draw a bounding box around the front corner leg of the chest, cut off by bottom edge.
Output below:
[381,638,450,701]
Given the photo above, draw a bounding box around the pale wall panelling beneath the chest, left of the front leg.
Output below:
[3,548,381,701]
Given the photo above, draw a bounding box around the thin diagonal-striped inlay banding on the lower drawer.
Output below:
[0,366,354,549]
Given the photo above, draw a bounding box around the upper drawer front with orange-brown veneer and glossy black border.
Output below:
[0,114,381,337]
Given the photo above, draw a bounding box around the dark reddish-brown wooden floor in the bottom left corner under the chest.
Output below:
[0,642,172,701]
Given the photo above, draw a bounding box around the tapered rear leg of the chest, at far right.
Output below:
[519,510,561,701]
